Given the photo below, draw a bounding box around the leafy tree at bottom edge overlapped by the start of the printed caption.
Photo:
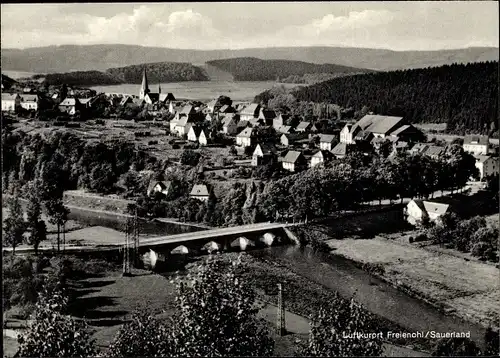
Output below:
[301,294,382,357]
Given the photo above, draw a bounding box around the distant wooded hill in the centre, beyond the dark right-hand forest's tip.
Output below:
[207,57,372,81]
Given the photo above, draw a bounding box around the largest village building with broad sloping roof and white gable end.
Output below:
[340,114,404,144]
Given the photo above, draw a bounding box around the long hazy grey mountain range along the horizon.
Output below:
[1,45,499,73]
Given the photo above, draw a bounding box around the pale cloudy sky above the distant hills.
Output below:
[1,1,499,51]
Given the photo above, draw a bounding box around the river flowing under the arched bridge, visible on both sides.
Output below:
[65,209,485,345]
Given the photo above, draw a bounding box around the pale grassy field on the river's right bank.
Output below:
[327,236,500,327]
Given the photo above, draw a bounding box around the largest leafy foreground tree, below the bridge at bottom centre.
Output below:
[171,258,274,357]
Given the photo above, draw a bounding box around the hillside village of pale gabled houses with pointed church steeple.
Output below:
[2,69,499,210]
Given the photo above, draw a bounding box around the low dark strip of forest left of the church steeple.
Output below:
[39,71,122,86]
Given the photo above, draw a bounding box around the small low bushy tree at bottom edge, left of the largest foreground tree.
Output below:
[106,310,171,357]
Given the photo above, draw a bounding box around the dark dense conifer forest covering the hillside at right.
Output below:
[288,62,499,135]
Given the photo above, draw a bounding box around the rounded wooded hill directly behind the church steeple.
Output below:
[106,62,209,84]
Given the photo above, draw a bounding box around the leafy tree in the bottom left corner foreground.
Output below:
[16,291,97,357]
